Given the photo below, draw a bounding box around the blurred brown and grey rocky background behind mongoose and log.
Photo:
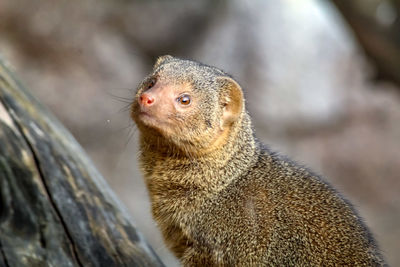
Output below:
[0,0,400,266]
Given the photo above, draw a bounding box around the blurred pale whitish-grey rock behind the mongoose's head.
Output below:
[196,0,355,134]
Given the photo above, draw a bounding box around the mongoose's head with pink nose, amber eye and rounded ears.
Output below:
[131,56,244,155]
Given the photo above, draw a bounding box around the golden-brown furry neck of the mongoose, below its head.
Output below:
[140,113,259,193]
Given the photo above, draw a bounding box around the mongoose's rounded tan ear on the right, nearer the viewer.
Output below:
[217,77,244,127]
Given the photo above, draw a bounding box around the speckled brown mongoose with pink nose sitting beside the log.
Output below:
[131,56,385,266]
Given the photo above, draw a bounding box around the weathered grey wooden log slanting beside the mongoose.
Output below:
[0,59,162,267]
